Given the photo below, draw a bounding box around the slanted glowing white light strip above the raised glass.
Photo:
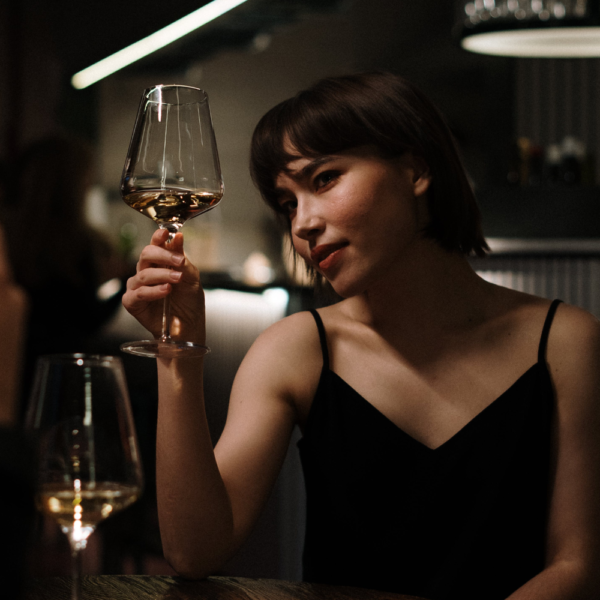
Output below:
[71,0,246,90]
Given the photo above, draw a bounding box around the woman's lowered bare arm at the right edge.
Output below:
[509,305,600,600]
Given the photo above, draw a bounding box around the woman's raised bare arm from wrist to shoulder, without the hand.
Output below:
[157,317,318,578]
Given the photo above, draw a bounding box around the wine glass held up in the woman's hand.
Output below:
[121,85,223,357]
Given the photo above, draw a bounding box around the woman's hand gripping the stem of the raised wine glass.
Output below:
[123,229,205,344]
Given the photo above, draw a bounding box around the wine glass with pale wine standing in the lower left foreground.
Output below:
[26,354,143,600]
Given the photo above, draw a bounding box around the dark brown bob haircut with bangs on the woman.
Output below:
[250,72,489,256]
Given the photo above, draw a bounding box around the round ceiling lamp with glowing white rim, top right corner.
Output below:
[458,0,600,58]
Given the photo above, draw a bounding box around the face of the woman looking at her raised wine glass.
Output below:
[276,147,430,298]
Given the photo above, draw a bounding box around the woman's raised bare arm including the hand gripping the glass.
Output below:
[124,231,320,578]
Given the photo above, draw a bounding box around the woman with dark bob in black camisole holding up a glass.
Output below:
[124,74,600,600]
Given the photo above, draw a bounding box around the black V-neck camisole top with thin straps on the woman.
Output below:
[298,300,560,600]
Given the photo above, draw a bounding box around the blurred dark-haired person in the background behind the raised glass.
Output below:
[2,135,128,413]
